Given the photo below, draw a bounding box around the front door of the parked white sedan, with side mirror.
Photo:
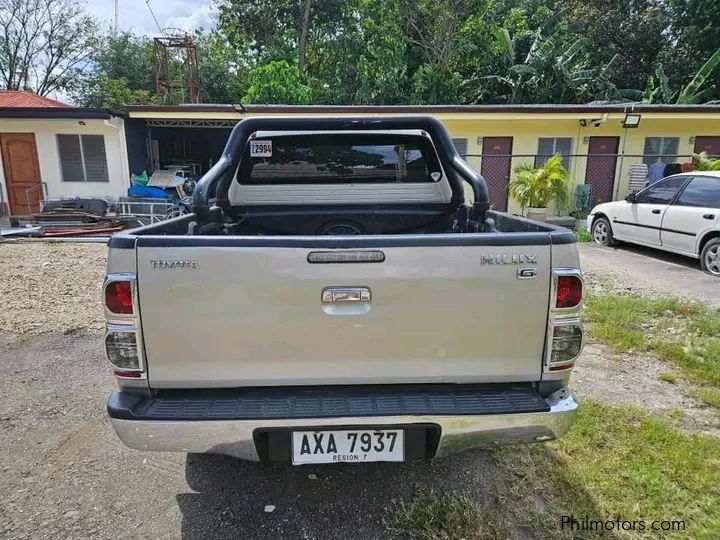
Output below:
[612,176,689,246]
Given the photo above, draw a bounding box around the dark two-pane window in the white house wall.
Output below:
[57,135,109,182]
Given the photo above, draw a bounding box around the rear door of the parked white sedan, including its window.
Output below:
[660,175,720,255]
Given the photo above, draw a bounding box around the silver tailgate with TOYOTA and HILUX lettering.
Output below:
[136,237,551,388]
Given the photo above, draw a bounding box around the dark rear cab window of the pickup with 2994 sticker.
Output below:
[237,134,443,185]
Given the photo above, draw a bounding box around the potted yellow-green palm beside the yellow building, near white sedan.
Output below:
[508,154,570,221]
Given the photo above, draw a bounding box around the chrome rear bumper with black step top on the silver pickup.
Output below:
[108,387,579,461]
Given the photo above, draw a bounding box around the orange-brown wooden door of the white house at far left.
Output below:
[0,133,43,214]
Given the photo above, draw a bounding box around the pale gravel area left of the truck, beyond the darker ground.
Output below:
[0,242,107,335]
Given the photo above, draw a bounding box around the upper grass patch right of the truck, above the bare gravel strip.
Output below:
[585,296,720,409]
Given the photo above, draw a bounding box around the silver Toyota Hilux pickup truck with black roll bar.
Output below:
[103,117,583,464]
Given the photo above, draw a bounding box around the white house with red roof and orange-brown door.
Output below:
[0,90,130,215]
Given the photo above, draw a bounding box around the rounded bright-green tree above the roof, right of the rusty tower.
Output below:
[243,60,312,105]
